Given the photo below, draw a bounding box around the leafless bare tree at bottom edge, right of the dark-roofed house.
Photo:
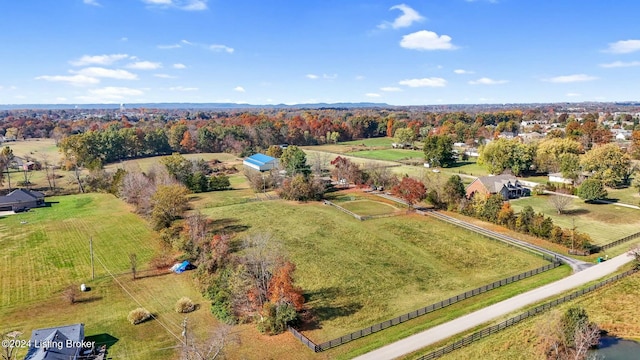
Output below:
[181,324,239,360]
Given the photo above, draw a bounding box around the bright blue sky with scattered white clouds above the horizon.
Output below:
[0,0,640,105]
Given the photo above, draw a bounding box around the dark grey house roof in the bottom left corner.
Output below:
[25,324,84,360]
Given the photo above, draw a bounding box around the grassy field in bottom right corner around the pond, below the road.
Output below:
[403,268,640,360]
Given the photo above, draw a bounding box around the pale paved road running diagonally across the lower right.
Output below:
[355,254,633,360]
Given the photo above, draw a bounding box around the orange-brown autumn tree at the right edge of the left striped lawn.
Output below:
[151,184,189,230]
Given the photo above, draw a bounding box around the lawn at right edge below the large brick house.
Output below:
[511,195,640,245]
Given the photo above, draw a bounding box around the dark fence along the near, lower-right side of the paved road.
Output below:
[417,269,638,360]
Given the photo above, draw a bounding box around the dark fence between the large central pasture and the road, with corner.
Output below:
[289,261,562,352]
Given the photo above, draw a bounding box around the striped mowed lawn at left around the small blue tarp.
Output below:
[0,194,217,360]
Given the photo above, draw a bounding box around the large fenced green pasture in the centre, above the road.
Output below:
[201,200,546,342]
